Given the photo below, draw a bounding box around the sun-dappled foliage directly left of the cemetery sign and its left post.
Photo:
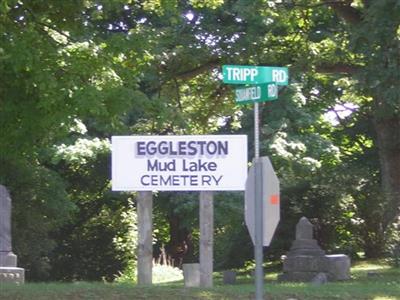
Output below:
[47,138,137,281]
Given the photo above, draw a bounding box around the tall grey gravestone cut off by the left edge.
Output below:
[0,185,25,283]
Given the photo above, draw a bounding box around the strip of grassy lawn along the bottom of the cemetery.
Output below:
[0,262,400,300]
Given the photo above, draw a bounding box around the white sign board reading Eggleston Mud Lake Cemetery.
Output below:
[112,135,247,191]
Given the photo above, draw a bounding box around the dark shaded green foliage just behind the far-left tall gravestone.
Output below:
[0,158,76,280]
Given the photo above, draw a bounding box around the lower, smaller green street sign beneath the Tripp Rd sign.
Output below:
[235,82,278,104]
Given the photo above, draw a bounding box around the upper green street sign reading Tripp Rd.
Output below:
[222,65,289,85]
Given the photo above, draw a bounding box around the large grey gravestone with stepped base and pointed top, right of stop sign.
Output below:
[279,217,350,282]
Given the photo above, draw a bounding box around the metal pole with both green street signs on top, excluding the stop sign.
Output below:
[222,65,289,300]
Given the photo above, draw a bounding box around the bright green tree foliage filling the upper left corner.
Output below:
[0,2,134,159]
